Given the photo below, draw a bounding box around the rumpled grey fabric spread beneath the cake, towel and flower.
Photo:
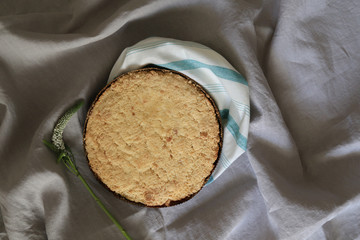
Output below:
[0,0,360,240]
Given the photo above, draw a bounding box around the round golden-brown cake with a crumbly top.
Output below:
[84,68,223,207]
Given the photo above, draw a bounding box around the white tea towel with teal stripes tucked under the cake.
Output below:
[109,37,250,183]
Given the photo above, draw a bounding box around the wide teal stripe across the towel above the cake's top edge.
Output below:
[158,59,248,86]
